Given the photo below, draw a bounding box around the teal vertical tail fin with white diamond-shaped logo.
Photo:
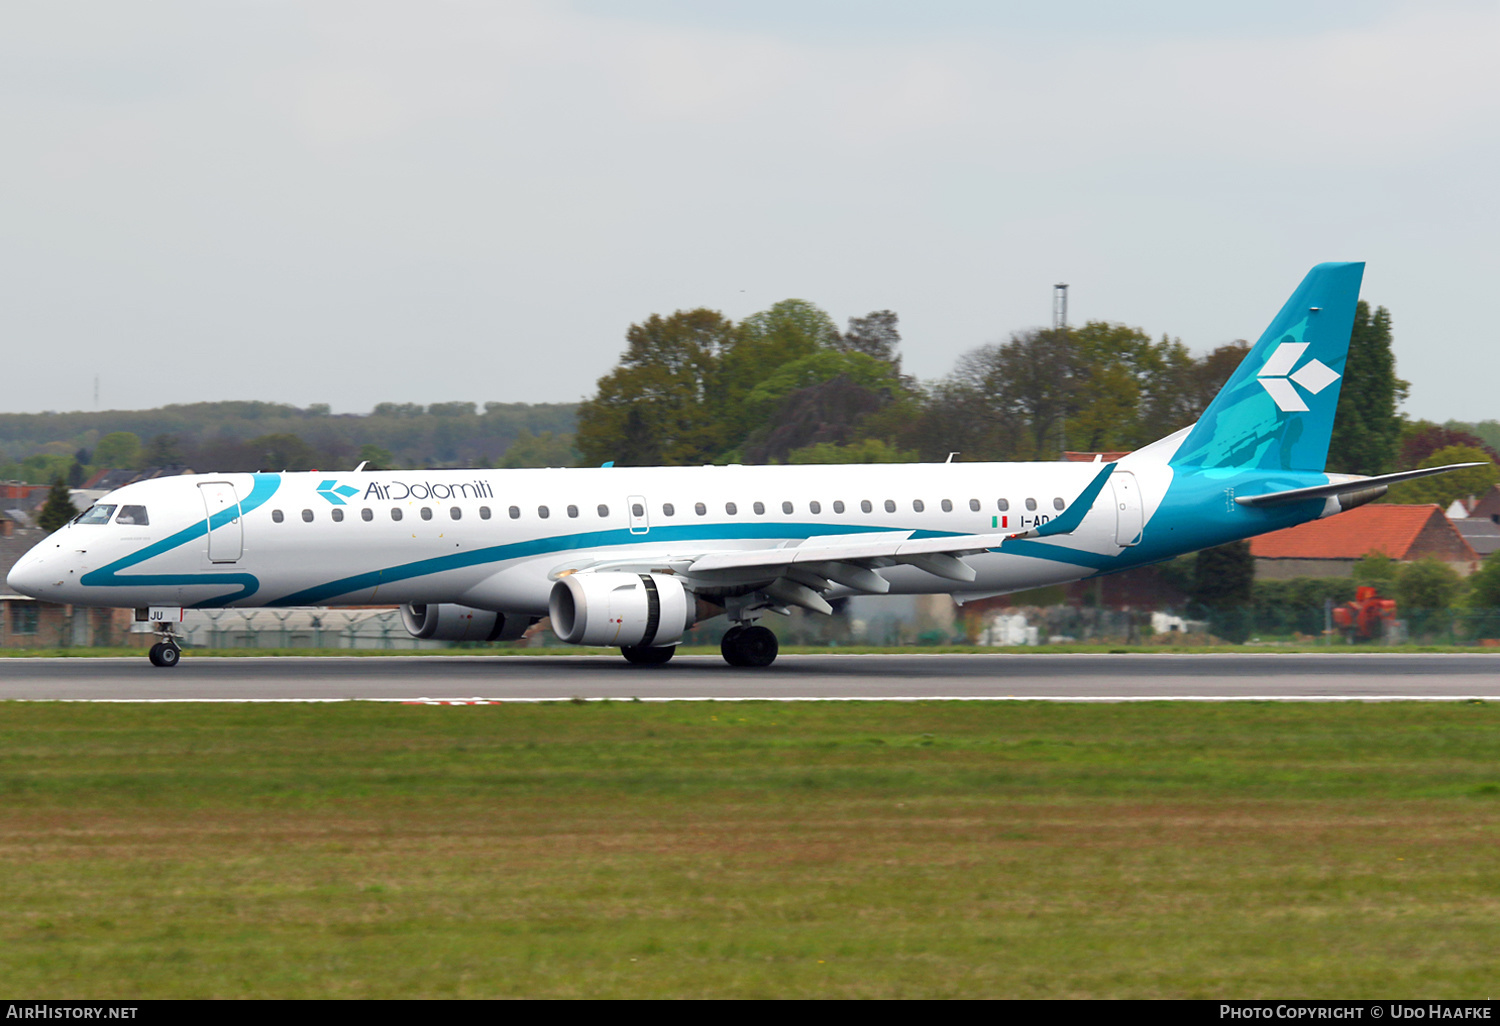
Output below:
[1172,263,1365,471]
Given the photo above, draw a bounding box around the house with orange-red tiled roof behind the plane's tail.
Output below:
[1250,503,1479,581]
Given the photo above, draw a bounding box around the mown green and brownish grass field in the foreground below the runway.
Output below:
[0,702,1500,998]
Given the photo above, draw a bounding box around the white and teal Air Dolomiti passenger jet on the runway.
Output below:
[8,263,1476,668]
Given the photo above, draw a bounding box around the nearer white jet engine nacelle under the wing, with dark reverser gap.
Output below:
[548,570,698,648]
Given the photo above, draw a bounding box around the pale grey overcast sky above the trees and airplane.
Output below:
[0,0,1500,420]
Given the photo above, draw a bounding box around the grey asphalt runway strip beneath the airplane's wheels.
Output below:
[0,653,1500,702]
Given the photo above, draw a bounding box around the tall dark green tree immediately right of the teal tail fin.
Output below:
[1328,300,1409,474]
